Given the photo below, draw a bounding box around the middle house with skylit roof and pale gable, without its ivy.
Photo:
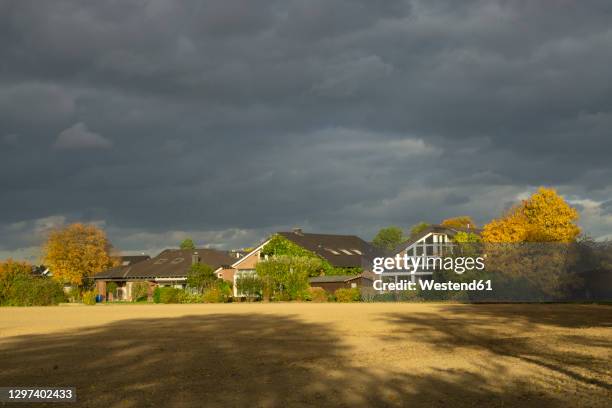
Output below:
[215,228,380,296]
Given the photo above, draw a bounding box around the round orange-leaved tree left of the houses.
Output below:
[43,223,118,286]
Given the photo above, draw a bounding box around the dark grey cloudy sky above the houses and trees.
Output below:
[0,0,612,258]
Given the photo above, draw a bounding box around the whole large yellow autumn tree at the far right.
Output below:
[482,187,581,300]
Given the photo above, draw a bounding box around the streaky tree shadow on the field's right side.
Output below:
[387,305,612,398]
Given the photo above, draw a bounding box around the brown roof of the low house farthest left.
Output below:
[94,248,236,279]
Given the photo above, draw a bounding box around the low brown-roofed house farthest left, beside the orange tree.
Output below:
[94,248,237,300]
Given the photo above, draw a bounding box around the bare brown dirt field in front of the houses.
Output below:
[0,304,612,407]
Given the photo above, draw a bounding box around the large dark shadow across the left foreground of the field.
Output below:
[0,314,576,407]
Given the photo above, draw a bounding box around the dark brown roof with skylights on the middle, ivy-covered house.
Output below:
[278,230,378,268]
